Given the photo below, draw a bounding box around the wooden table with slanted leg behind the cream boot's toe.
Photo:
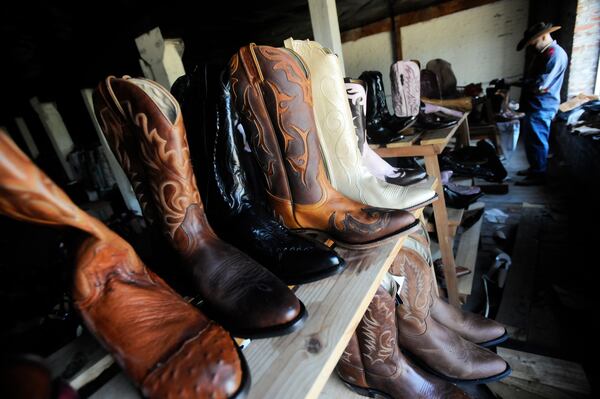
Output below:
[371,112,470,306]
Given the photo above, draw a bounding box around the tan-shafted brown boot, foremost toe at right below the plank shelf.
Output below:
[390,248,511,383]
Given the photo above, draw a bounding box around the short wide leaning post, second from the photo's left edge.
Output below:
[29,97,76,180]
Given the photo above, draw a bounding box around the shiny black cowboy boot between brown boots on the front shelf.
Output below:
[172,73,345,284]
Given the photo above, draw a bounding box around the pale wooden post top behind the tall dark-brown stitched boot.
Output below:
[135,27,185,90]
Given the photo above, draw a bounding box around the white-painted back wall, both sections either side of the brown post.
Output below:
[343,0,529,106]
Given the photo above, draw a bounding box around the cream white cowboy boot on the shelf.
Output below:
[285,39,437,210]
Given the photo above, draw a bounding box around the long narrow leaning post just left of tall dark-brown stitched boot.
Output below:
[81,89,142,215]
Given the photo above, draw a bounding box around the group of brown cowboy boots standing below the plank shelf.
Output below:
[337,227,511,398]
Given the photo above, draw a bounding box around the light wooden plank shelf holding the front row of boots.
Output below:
[48,234,408,399]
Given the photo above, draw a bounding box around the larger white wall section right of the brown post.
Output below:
[401,0,529,85]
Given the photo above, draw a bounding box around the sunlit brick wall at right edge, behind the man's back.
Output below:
[569,0,600,96]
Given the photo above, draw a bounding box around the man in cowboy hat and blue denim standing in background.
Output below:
[516,22,568,186]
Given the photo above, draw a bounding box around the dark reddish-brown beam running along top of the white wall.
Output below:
[342,0,498,42]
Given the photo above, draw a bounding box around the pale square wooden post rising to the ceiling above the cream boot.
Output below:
[308,0,346,76]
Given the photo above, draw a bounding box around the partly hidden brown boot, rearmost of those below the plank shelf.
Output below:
[403,227,508,347]
